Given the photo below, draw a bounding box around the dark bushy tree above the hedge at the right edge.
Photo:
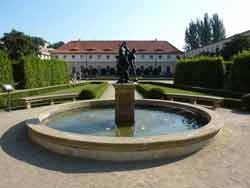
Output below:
[221,35,250,60]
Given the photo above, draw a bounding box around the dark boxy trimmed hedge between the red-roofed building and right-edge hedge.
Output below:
[174,56,225,89]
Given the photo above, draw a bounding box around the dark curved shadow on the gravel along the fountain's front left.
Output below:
[0,122,191,173]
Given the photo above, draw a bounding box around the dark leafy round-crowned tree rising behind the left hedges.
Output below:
[1,30,39,60]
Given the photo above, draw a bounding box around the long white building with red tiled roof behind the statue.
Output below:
[51,40,182,79]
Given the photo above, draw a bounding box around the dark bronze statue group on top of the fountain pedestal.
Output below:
[117,42,137,83]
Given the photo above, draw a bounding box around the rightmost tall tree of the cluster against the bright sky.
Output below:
[210,14,226,42]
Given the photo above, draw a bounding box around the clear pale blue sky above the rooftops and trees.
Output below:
[0,0,250,50]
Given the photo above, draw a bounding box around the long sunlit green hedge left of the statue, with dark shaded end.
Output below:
[14,56,69,88]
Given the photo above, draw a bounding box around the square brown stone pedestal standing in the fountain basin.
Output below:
[113,83,136,127]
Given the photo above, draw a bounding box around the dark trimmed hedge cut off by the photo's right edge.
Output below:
[230,51,250,93]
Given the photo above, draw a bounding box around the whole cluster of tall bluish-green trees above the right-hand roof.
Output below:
[185,13,226,51]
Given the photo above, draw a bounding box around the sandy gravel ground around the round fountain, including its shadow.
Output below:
[0,85,250,188]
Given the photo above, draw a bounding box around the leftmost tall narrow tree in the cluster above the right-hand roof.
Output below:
[185,20,200,50]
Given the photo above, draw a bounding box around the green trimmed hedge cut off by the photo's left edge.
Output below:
[0,50,13,85]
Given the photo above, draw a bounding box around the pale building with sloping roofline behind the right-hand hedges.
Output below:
[184,30,250,57]
